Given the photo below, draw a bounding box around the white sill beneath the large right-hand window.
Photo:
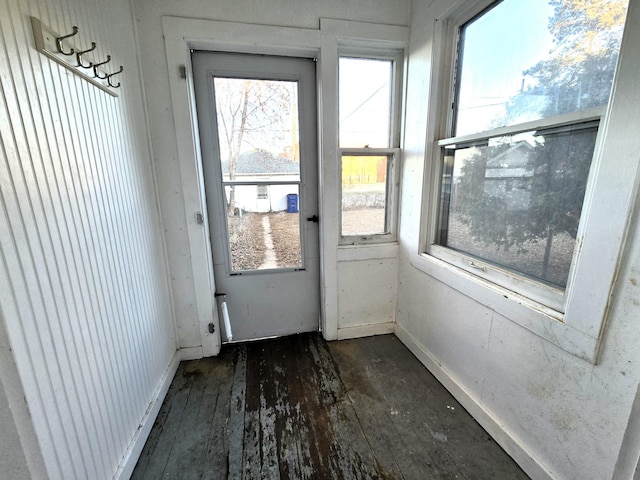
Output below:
[411,254,599,364]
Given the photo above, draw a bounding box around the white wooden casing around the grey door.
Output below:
[162,17,330,357]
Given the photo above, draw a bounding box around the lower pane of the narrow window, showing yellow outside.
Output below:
[342,156,388,235]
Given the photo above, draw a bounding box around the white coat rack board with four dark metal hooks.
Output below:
[31,17,124,97]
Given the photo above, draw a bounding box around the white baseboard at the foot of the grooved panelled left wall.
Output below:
[113,351,180,480]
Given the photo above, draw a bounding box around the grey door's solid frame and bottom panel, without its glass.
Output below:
[191,50,320,343]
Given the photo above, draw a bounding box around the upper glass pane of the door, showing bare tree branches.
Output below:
[214,78,300,181]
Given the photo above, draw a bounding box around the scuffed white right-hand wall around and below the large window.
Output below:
[396,0,640,480]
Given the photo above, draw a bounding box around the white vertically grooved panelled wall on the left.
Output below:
[0,0,176,479]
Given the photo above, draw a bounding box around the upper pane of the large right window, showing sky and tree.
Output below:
[454,0,628,135]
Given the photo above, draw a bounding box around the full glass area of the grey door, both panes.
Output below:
[214,77,303,273]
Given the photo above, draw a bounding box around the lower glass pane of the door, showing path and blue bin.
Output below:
[225,184,302,272]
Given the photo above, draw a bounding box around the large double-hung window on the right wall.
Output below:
[426,0,626,312]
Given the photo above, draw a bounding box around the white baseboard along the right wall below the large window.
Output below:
[394,323,556,480]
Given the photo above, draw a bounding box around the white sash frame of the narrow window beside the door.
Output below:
[337,46,404,246]
